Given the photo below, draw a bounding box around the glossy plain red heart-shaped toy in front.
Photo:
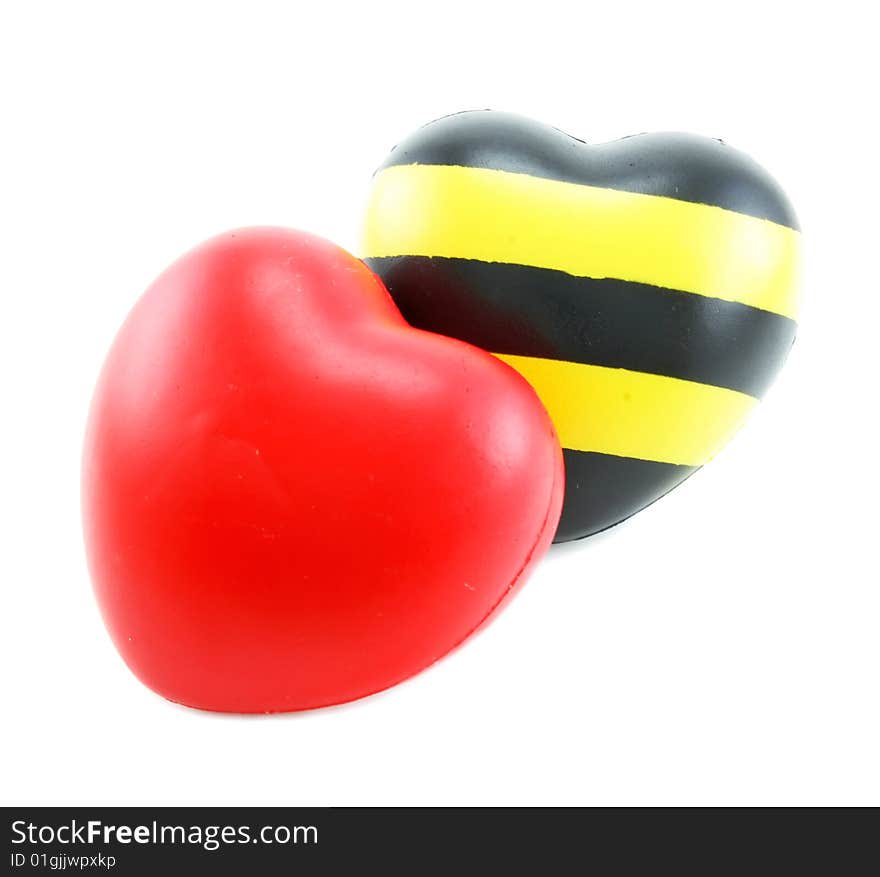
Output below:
[83,229,563,712]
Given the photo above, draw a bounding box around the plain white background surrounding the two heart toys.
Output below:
[0,0,880,804]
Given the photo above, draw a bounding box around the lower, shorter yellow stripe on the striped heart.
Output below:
[495,354,757,466]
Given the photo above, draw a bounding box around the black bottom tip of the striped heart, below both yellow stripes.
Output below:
[553,448,699,542]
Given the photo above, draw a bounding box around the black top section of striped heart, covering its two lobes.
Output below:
[382,110,798,228]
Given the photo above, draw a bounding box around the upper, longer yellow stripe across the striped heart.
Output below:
[363,165,800,317]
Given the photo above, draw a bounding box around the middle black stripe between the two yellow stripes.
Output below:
[366,256,797,396]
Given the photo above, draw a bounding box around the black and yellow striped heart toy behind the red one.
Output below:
[363,111,800,541]
